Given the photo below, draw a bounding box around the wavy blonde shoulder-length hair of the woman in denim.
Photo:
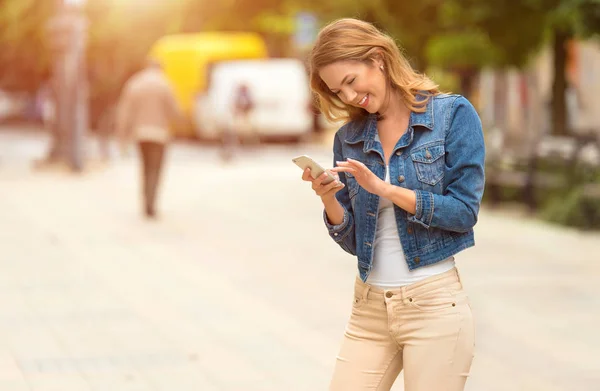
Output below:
[308,18,440,122]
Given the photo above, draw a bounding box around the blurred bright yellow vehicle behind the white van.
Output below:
[150,32,268,136]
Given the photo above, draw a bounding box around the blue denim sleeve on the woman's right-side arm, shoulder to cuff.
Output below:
[409,97,485,232]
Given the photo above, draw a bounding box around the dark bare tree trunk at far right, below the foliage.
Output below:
[552,29,571,136]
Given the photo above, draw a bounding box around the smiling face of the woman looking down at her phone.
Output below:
[319,61,387,114]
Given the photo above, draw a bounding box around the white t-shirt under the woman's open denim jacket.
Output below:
[367,166,454,289]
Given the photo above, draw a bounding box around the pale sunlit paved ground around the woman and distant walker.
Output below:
[0,132,600,391]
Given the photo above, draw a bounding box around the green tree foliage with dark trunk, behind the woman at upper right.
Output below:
[304,0,600,139]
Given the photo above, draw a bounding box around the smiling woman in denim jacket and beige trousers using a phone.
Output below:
[302,19,485,391]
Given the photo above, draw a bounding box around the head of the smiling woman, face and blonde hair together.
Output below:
[311,18,439,122]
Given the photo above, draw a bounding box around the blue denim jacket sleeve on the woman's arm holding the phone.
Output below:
[323,134,356,255]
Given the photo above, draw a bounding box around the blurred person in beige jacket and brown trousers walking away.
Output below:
[117,59,182,218]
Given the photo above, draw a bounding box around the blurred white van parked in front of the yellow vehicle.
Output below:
[192,59,313,140]
